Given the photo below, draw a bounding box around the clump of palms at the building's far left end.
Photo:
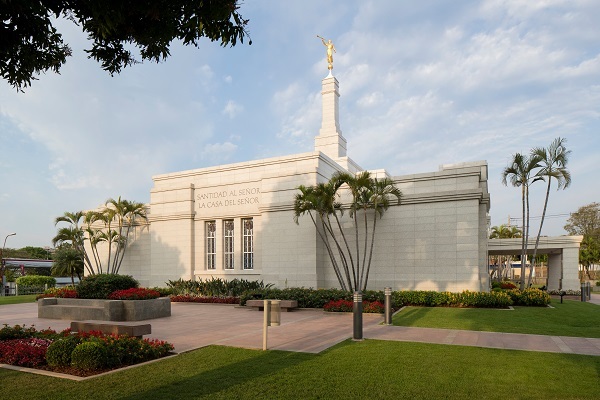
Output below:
[52,197,147,275]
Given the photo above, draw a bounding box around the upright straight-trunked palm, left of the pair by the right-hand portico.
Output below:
[502,153,542,290]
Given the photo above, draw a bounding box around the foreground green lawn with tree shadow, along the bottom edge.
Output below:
[0,340,600,400]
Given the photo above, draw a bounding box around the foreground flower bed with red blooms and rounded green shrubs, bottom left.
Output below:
[0,325,173,376]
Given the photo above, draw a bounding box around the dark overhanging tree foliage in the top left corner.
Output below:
[0,0,252,90]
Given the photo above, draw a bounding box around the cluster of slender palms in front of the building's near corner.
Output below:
[294,171,402,291]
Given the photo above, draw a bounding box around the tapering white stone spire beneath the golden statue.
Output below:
[315,76,346,160]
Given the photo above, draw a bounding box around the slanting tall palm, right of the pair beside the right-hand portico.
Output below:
[528,137,571,285]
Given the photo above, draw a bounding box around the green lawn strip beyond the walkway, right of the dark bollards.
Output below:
[393,300,600,338]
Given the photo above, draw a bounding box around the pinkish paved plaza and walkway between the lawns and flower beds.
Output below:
[0,294,600,356]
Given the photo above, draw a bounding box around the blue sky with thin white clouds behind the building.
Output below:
[0,0,600,248]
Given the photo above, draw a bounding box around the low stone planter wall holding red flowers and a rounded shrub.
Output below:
[38,297,171,321]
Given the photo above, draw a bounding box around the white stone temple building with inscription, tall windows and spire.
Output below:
[112,77,490,291]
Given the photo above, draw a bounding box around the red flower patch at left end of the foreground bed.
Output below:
[0,338,51,367]
